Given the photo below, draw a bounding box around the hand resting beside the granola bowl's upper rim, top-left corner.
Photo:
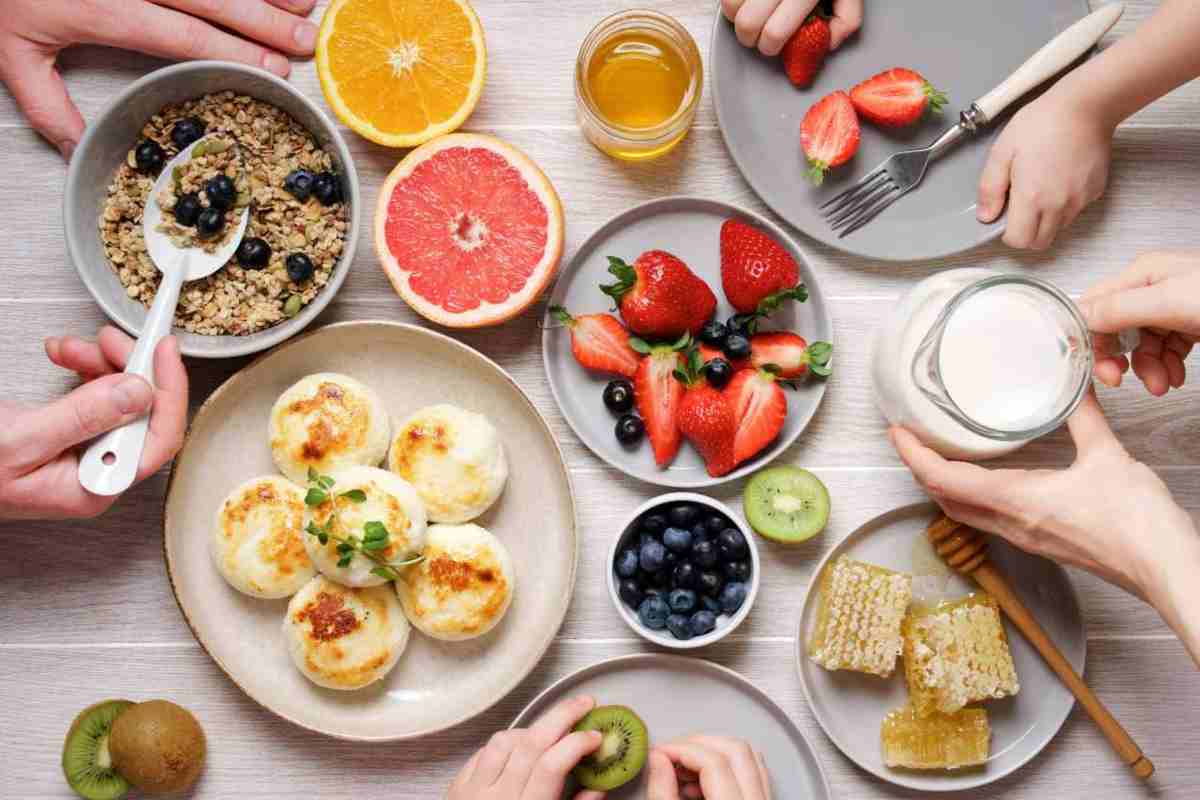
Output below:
[0,0,317,158]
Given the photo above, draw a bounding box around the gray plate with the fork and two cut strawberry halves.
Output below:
[709,0,1087,260]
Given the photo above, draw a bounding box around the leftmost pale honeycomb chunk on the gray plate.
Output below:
[809,557,912,678]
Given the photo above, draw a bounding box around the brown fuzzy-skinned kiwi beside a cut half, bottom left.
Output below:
[108,700,208,794]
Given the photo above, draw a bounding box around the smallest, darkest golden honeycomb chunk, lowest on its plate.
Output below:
[880,705,991,770]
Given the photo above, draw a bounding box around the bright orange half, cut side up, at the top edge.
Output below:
[317,0,487,148]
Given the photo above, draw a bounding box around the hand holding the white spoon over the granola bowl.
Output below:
[0,327,187,518]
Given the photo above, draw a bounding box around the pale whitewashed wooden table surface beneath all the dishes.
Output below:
[0,0,1200,800]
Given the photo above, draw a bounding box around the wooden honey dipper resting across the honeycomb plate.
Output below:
[925,516,1154,780]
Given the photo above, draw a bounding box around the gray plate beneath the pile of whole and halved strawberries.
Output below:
[541,197,838,488]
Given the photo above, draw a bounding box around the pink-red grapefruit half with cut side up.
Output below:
[374,133,563,327]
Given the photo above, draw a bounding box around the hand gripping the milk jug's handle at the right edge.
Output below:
[1079,252,1200,397]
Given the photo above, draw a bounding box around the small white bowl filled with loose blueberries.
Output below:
[605,492,762,650]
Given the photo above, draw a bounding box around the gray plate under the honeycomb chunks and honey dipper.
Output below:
[797,503,1087,792]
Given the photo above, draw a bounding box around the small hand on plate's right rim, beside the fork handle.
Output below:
[976,86,1116,249]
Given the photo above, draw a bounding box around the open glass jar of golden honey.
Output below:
[575,10,704,161]
